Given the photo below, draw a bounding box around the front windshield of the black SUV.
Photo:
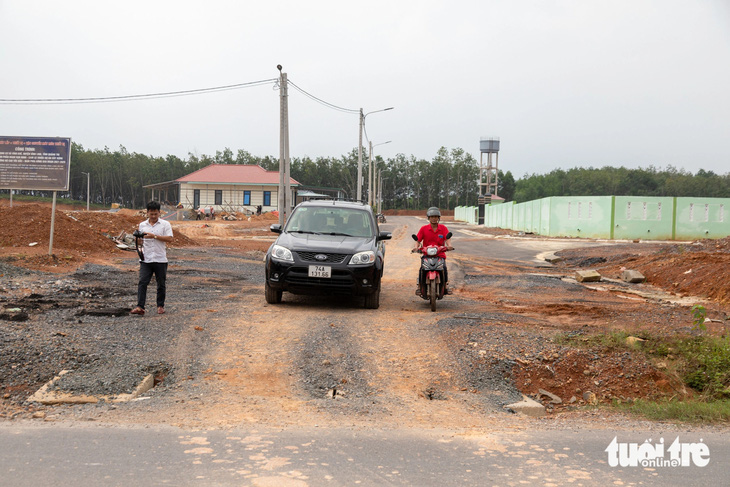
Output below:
[284,206,374,237]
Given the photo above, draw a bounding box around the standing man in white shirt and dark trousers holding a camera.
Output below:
[131,201,172,315]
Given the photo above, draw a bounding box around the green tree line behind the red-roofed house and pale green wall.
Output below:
[2,143,730,209]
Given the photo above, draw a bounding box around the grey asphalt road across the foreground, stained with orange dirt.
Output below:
[0,423,730,487]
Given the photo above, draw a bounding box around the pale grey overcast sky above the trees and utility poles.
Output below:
[0,0,730,178]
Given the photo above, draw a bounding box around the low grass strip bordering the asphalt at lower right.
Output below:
[615,399,730,423]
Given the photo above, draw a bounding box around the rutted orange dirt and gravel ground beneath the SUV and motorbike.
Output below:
[0,208,728,431]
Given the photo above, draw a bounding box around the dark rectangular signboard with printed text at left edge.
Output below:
[0,136,71,191]
